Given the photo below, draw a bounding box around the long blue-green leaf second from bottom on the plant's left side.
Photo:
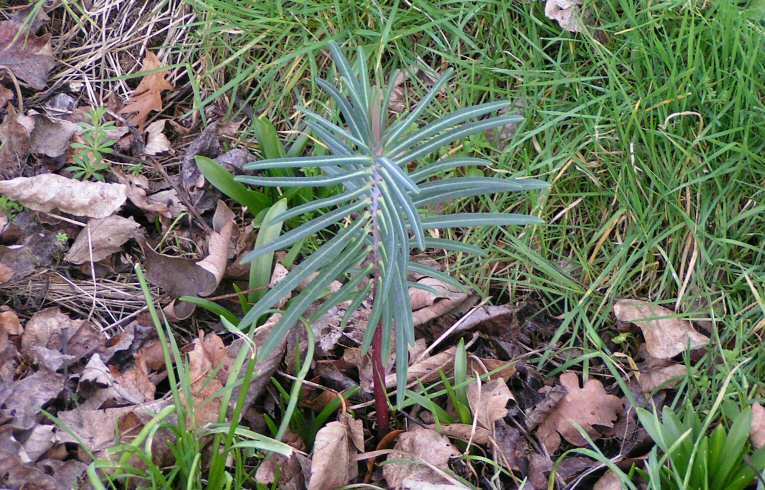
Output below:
[237,220,363,331]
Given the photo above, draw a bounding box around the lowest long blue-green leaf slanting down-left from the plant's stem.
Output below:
[258,235,364,358]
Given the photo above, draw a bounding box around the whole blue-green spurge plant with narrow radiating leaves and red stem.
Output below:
[237,44,547,425]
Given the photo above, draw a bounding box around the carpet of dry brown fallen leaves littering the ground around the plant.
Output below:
[0,0,736,489]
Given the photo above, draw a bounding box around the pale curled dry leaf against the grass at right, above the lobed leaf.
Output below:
[614,299,709,359]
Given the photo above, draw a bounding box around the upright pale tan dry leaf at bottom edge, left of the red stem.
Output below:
[308,421,363,490]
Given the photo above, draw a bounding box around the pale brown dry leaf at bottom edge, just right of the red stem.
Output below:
[383,427,459,489]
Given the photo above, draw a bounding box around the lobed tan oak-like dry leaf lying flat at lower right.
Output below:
[537,372,623,454]
